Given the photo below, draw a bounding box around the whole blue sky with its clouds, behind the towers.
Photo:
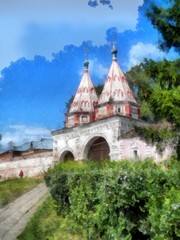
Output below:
[0,0,177,149]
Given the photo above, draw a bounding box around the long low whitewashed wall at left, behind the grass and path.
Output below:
[0,154,53,179]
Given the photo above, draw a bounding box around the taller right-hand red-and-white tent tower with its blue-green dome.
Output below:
[95,45,140,120]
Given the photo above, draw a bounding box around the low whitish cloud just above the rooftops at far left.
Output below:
[0,125,51,147]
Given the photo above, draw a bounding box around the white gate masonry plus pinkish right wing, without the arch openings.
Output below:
[53,116,172,161]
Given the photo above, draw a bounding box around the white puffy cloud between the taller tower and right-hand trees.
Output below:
[128,42,165,68]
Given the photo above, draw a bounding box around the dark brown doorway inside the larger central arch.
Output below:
[88,137,110,161]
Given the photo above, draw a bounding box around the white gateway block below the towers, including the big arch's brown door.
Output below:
[52,116,141,161]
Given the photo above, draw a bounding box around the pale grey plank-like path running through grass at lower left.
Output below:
[0,183,48,240]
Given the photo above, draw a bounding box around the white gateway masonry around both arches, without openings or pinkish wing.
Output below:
[53,116,145,161]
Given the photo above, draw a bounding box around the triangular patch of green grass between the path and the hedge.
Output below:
[17,197,85,240]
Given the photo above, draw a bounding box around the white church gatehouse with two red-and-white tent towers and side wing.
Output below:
[52,47,171,161]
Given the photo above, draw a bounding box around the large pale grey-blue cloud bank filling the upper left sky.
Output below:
[0,0,143,70]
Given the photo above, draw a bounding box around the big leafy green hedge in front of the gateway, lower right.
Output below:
[45,160,180,240]
